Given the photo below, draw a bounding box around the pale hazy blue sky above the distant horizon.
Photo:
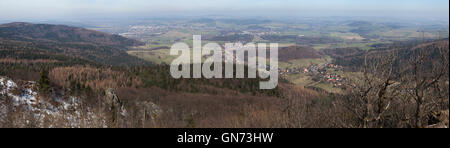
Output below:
[0,0,449,20]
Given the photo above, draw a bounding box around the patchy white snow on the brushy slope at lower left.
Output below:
[0,76,106,128]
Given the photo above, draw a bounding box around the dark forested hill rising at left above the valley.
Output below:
[0,23,146,65]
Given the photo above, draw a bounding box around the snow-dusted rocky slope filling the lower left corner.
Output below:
[0,76,107,128]
